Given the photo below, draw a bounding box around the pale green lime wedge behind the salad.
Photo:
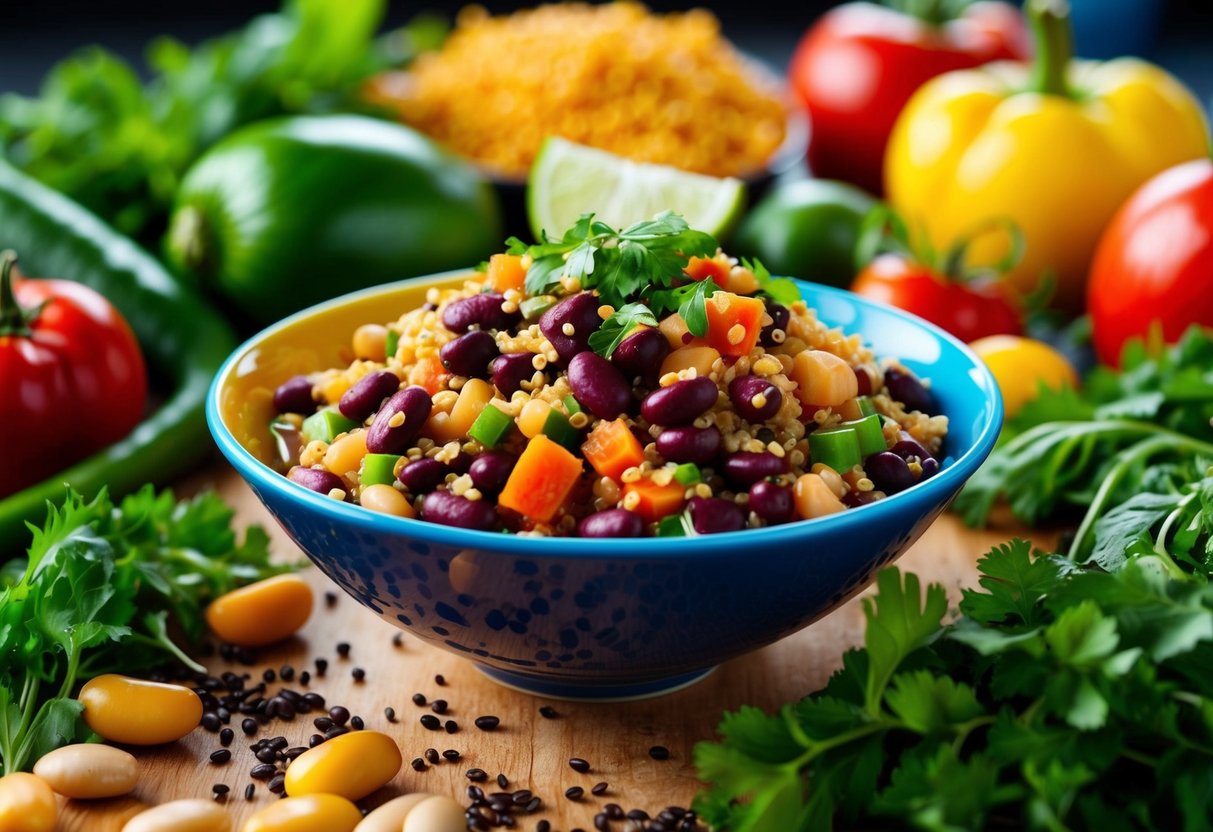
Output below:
[526,136,746,240]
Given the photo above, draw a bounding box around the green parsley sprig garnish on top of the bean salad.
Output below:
[506,211,801,358]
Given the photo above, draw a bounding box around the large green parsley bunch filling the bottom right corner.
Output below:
[695,543,1213,832]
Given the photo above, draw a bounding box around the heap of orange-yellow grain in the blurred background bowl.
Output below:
[371,2,787,177]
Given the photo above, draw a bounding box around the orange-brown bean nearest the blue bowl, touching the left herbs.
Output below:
[206,575,312,648]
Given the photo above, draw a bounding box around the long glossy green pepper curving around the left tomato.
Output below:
[0,161,235,553]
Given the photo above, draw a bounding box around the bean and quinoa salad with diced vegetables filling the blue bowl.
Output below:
[272,212,947,537]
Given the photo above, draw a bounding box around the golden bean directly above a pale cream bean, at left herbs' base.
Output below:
[79,673,203,746]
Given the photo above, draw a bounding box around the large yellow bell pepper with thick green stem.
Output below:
[884,0,1209,310]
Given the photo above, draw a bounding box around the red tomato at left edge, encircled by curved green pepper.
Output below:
[0,253,147,497]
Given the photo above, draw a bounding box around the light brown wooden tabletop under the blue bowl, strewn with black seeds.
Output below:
[58,465,1043,832]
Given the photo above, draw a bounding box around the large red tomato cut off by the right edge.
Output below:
[1087,159,1213,366]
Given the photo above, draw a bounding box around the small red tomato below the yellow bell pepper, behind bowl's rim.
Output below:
[850,253,1023,342]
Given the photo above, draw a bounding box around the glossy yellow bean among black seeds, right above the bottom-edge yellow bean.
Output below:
[285,731,404,800]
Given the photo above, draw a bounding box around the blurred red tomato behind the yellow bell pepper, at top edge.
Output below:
[788,2,1030,194]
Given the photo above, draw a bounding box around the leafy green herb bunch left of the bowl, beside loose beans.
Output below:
[0,486,292,774]
